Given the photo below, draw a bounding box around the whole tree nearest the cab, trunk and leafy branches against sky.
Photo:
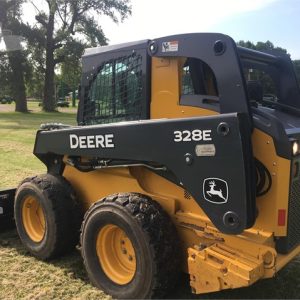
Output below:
[30,0,131,111]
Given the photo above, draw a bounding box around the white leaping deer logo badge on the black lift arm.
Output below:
[203,178,228,204]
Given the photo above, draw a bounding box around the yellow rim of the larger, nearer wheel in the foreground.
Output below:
[96,224,136,285]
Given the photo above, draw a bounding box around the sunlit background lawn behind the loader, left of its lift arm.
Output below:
[0,103,76,188]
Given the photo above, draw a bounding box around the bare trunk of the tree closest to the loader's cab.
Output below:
[43,12,56,112]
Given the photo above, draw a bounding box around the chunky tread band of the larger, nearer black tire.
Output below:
[80,193,180,298]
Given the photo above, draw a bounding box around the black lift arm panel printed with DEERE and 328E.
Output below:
[34,113,255,234]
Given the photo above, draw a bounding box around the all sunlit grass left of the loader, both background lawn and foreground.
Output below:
[0,103,109,299]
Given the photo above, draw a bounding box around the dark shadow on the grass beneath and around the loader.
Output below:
[0,229,300,299]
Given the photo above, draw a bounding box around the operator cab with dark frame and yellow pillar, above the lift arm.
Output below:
[78,33,300,159]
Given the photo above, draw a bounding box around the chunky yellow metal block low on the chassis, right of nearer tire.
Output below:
[188,244,264,294]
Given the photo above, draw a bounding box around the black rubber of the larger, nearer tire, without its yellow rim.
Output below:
[81,193,180,299]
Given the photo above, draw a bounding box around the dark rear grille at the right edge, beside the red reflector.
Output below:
[276,173,300,254]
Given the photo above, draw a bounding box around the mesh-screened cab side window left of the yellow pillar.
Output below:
[84,54,143,124]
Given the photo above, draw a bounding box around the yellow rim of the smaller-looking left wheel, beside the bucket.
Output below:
[22,196,46,243]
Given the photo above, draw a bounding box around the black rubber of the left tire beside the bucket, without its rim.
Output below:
[14,174,82,260]
